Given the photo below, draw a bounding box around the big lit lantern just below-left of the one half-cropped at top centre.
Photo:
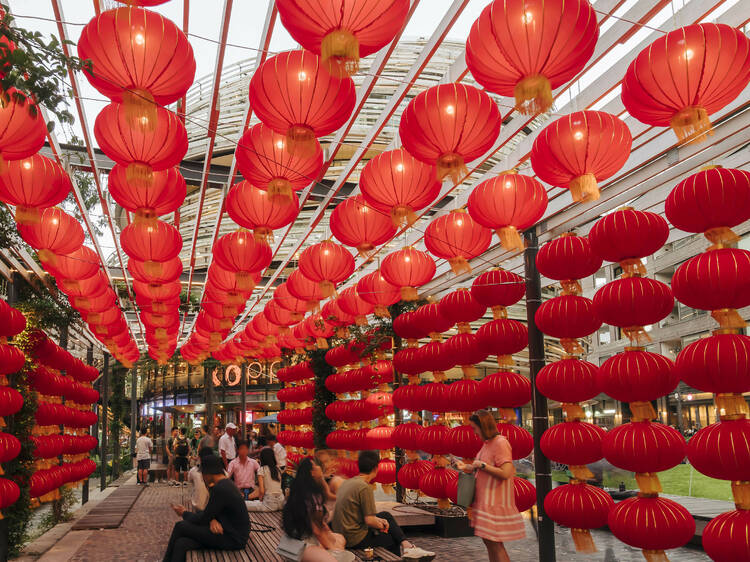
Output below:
[250,50,356,151]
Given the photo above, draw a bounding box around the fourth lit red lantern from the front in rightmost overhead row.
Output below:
[424,211,492,275]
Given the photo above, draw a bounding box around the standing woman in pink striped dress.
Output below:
[458,410,526,562]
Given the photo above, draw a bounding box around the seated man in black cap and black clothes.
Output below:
[164,454,250,562]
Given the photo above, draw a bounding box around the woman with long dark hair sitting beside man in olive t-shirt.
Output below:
[284,458,353,562]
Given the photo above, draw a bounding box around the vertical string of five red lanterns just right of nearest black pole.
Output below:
[536,233,614,552]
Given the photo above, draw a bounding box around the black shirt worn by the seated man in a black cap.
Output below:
[182,478,250,548]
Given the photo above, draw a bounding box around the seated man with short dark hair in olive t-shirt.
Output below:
[333,451,435,560]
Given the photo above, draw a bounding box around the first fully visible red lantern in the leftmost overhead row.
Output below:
[18,207,85,261]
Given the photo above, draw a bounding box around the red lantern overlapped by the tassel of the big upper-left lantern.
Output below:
[94,103,188,186]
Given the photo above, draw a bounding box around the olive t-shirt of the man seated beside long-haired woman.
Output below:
[332,476,375,548]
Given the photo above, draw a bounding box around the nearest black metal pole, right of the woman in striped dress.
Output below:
[524,230,555,562]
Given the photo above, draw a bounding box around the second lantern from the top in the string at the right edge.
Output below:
[672,248,750,329]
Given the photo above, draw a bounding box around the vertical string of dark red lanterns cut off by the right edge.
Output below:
[665,168,750,561]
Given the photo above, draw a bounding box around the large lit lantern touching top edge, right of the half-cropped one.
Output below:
[466,0,599,115]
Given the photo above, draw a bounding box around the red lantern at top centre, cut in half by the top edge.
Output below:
[277,0,409,76]
